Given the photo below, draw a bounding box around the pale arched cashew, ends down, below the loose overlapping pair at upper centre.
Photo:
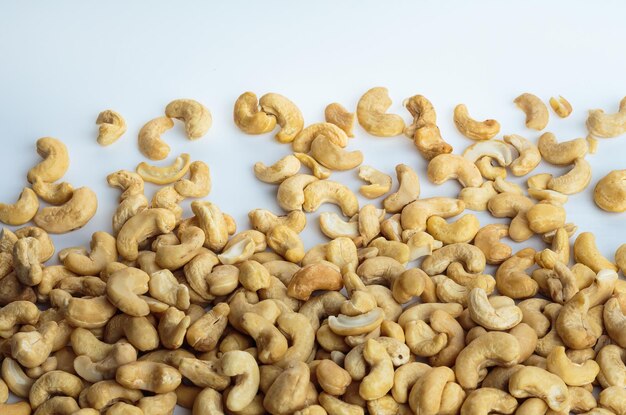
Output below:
[302,179,359,217]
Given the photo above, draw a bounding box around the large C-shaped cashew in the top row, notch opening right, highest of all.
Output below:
[356,87,405,137]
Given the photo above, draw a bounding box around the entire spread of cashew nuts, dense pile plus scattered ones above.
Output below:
[0,92,626,415]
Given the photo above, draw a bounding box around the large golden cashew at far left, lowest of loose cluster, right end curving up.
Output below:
[34,187,98,233]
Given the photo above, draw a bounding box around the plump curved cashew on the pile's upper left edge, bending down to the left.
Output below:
[117,210,176,261]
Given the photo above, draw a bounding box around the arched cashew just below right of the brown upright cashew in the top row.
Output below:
[427,154,483,187]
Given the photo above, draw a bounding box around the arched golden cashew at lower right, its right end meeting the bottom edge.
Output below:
[509,366,570,413]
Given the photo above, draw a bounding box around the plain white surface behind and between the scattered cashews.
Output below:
[0,0,626,412]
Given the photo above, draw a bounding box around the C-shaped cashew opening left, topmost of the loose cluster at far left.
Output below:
[27,137,70,183]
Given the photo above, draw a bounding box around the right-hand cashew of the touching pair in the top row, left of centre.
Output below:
[259,93,304,143]
